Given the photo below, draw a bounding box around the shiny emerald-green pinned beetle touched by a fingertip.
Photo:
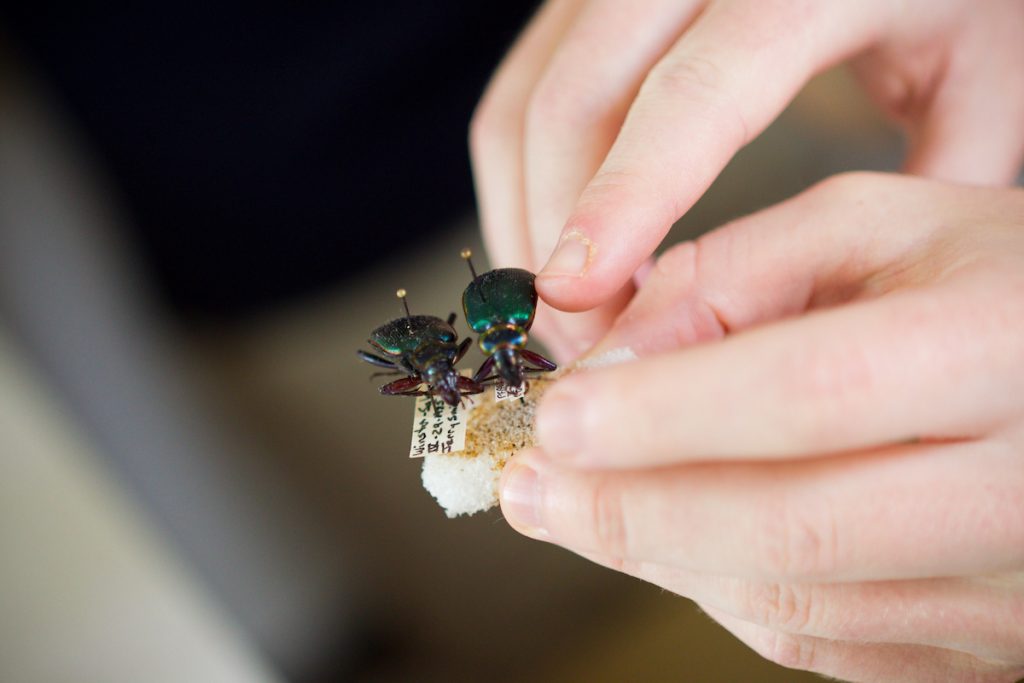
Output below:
[462,249,558,387]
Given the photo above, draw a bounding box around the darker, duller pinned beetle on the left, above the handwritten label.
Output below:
[357,290,483,405]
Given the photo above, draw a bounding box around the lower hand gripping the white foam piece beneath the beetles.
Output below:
[501,174,1024,681]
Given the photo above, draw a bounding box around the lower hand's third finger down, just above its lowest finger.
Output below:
[580,552,1024,661]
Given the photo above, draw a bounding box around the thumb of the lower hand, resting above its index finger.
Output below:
[591,173,950,356]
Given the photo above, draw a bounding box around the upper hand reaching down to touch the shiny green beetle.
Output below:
[470,0,1024,361]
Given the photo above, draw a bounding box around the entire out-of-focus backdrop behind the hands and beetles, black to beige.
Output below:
[0,5,900,683]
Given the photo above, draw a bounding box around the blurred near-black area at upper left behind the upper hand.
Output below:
[0,0,536,317]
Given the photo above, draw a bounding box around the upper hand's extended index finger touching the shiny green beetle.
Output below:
[538,0,888,310]
